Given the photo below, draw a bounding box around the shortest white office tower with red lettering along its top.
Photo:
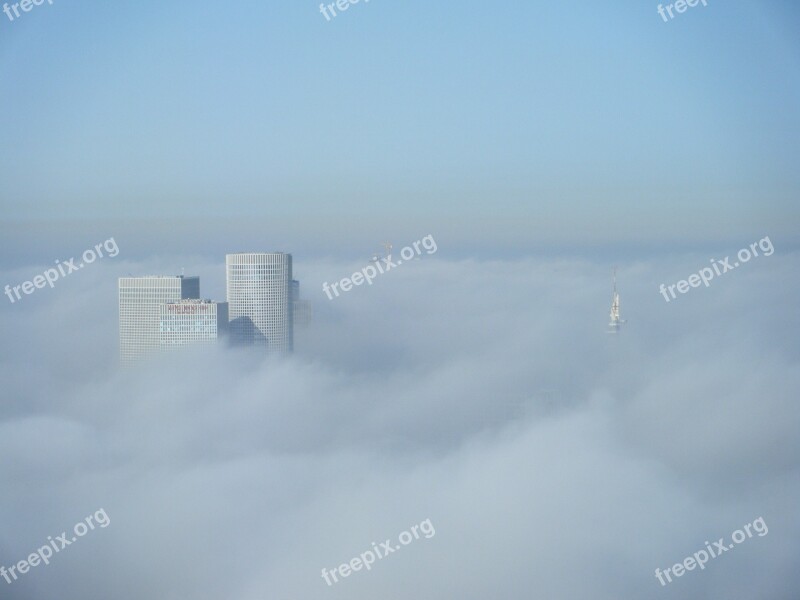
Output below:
[159,300,228,350]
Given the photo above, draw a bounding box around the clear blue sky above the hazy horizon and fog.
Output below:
[0,0,800,241]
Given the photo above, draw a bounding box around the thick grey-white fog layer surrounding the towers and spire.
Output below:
[0,246,800,600]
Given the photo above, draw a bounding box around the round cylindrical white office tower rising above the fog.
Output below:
[225,252,294,353]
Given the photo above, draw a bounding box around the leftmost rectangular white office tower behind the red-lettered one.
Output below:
[119,275,200,363]
